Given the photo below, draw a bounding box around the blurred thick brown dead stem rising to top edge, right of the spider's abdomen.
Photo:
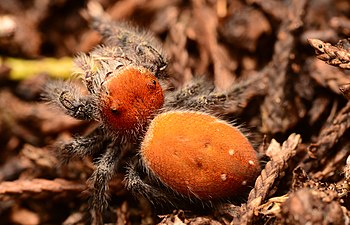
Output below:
[261,0,306,133]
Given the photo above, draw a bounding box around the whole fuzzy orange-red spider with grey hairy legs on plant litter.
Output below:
[44,2,259,223]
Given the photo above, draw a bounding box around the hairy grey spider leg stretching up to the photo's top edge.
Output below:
[87,2,168,78]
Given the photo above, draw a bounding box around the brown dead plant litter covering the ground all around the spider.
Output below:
[0,0,350,225]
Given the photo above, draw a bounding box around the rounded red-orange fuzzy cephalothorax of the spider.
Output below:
[101,67,164,133]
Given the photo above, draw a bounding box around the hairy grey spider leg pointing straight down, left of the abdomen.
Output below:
[89,140,121,214]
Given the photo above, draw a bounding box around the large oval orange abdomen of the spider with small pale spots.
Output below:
[140,111,260,200]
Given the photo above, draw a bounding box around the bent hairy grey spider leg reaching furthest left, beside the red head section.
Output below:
[42,80,99,120]
